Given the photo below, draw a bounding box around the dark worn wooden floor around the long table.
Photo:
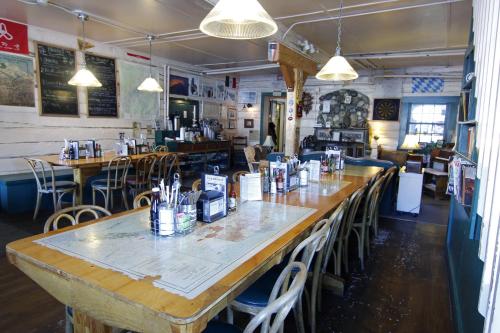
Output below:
[0,197,453,333]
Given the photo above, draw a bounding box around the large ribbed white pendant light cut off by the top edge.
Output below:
[200,0,278,39]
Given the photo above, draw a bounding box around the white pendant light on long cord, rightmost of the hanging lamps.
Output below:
[316,0,359,81]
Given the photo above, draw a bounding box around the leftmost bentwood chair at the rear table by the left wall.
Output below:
[25,158,77,220]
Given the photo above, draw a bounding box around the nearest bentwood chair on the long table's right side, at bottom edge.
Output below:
[203,262,307,333]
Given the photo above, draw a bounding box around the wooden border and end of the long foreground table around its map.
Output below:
[7,166,382,332]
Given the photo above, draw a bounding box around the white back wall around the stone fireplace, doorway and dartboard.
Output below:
[238,66,462,149]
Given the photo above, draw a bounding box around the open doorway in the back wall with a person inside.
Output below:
[260,93,286,152]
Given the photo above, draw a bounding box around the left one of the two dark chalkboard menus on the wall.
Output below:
[36,43,78,116]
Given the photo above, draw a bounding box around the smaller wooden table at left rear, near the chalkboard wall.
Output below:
[37,152,175,205]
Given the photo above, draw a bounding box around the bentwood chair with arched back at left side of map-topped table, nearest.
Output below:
[43,205,111,333]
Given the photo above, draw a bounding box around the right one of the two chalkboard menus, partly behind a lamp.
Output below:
[85,54,118,117]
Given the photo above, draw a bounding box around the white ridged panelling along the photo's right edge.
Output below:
[473,0,500,333]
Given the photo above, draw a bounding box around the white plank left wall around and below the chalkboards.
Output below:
[0,26,191,175]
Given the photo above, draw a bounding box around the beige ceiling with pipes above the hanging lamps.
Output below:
[0,0,472,68]
